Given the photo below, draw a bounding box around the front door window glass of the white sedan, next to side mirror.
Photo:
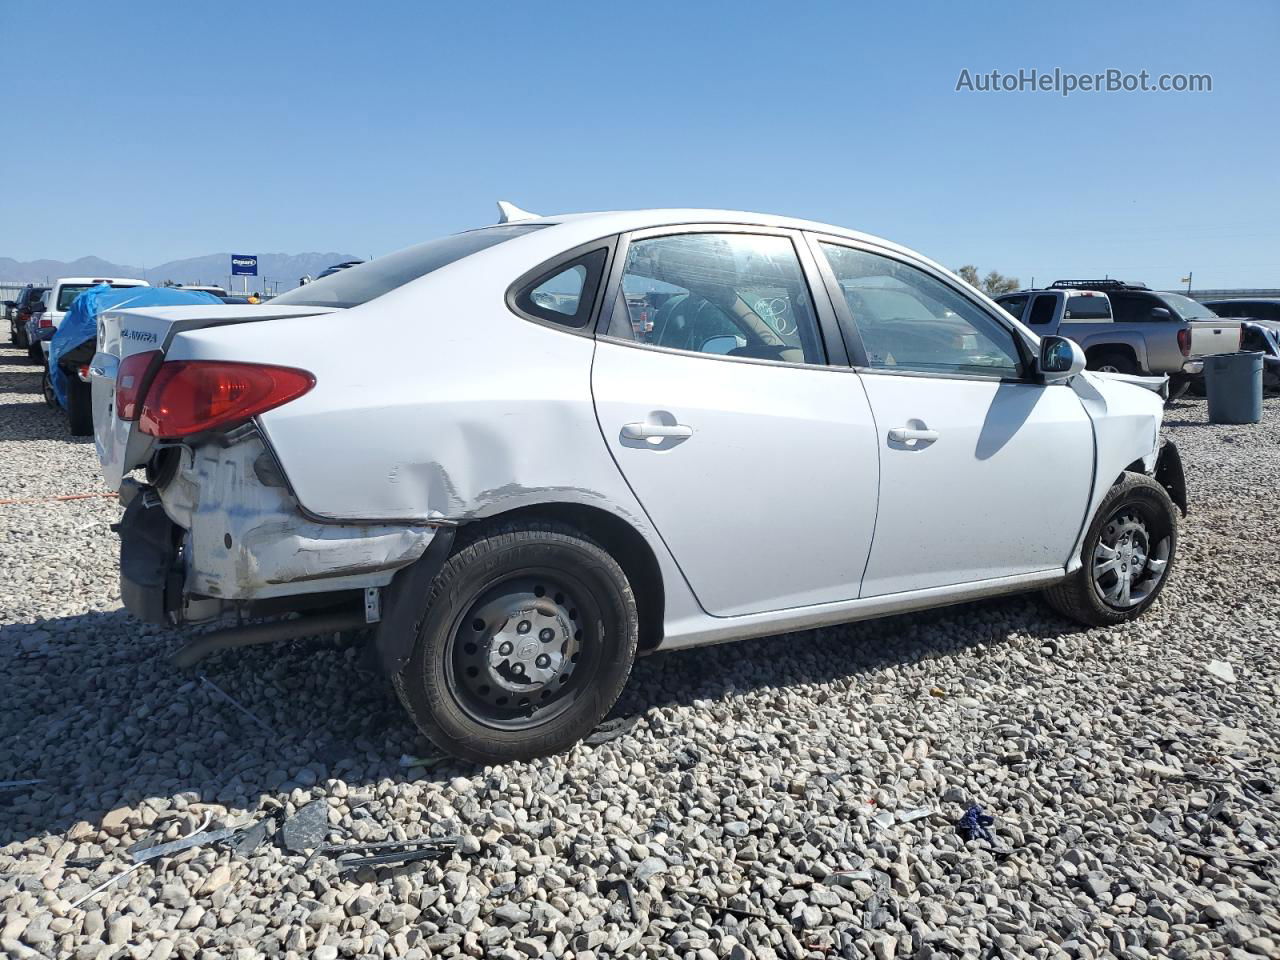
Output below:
[820,243,1034,378]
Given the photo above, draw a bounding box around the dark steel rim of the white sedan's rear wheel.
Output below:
[444,570,600,730]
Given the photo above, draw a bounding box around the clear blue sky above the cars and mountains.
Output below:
[0,0,1280,287]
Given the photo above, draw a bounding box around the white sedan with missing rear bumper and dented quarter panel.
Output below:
[91,205,1187,762]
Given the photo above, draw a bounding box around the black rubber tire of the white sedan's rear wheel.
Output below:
[392,521,639,763]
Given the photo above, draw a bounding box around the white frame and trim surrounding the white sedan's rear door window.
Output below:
[595,223,849,370]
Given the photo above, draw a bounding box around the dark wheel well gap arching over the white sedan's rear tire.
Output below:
[454,503,666,653]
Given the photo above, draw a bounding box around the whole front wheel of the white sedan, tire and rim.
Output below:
[1044,474,1178,627]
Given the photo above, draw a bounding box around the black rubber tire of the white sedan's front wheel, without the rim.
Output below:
[1044,472,1178,627]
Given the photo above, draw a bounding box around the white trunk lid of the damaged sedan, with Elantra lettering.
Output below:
[90,303,333,490]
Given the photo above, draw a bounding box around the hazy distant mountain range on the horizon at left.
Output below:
[0,253,357,292]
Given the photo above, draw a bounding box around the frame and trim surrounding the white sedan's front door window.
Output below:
[804,230,1041,383]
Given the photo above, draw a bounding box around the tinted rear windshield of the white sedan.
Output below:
[273,224,548,307]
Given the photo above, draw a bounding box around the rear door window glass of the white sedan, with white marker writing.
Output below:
[608,233,824,364]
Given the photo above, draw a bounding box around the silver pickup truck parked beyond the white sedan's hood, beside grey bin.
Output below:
[996,280,1202,397]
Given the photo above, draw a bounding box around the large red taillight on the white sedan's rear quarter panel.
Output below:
[138,360,316,439]
